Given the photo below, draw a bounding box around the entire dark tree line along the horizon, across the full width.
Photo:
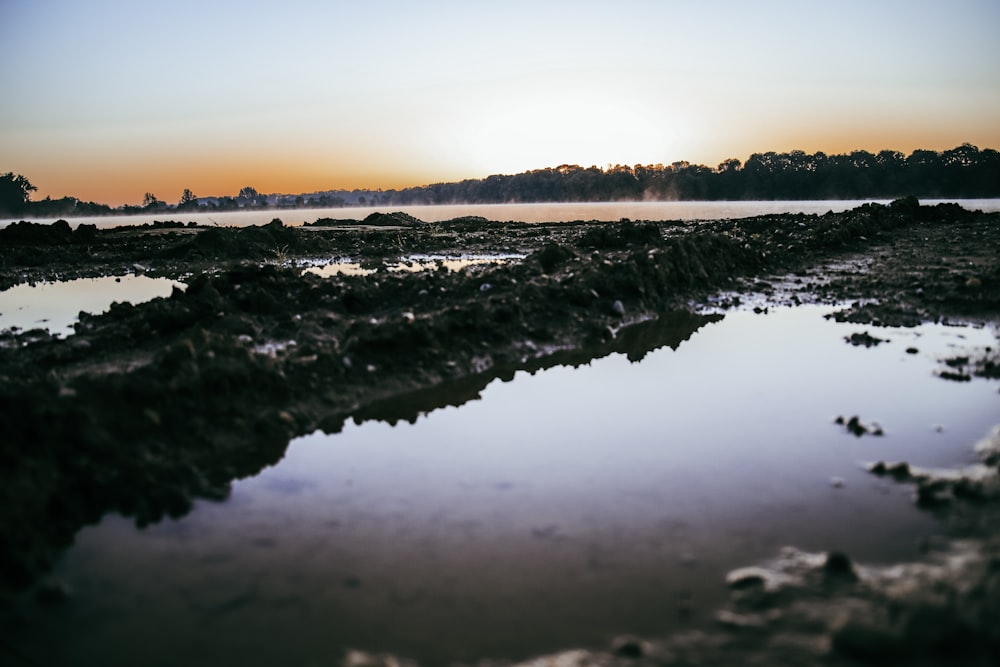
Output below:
[0,144,1000,217]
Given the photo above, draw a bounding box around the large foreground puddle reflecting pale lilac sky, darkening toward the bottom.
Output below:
[19,308,1000,665]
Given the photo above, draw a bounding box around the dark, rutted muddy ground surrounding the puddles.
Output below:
[0,199,1000,667]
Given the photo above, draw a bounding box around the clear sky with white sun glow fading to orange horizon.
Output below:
[0,0,1000,205]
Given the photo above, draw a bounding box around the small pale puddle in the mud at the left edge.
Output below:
[0,274,185,336]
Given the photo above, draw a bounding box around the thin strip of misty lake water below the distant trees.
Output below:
[0,199,1000,227]
